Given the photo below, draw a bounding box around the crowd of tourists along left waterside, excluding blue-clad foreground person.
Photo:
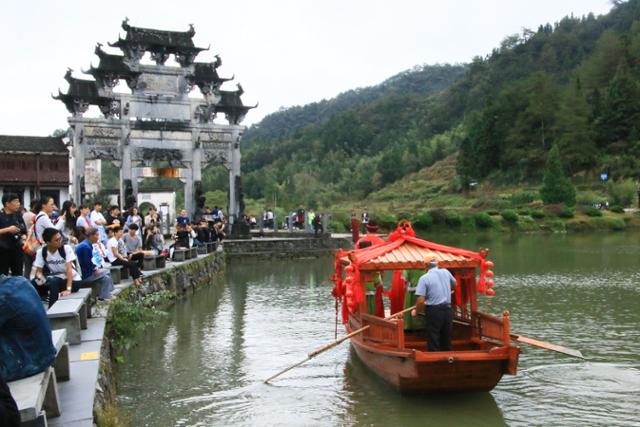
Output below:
[0,193,226,305]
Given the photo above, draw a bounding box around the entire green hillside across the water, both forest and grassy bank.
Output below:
[235,0,640,230]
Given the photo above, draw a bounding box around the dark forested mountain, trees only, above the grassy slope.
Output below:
[238,0,640,211]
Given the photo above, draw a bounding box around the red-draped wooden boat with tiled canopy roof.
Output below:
[332,234,520,393]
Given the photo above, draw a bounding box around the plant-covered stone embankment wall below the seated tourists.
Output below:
[94,253,225,414]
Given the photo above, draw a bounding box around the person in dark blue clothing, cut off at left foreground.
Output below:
[0,274,56,381]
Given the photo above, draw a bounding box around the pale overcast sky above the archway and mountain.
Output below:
[0,0,611,135]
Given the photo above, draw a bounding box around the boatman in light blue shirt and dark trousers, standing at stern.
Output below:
[411,258,456,351]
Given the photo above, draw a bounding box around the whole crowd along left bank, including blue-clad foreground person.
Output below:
[0,193,226,408]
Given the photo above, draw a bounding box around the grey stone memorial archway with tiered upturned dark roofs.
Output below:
[54,19,254,232]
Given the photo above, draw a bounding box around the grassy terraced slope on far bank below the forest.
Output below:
[238,155,640,232]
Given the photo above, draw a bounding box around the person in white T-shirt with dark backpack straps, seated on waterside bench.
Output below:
[31,228,82,307]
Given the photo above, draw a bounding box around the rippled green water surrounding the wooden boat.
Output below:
[118,233,640,427]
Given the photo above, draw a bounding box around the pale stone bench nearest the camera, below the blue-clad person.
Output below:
[8,367,60,427]
